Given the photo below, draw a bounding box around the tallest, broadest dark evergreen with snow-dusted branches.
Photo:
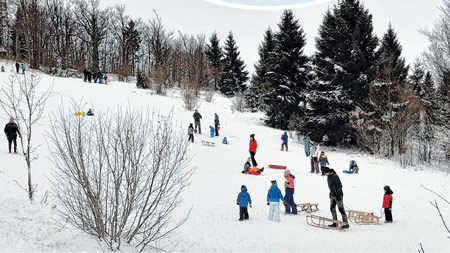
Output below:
[300,0,378,145]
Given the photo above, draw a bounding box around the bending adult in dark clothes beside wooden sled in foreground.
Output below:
[322,167,349,228]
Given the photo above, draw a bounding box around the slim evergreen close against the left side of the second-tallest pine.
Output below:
[245,28,275,112]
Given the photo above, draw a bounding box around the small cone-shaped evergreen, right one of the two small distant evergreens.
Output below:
[219,32,248,97]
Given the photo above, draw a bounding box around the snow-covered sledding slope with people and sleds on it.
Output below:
[0,62,450,252]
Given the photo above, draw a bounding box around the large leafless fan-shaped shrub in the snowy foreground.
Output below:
[47,103,194,251]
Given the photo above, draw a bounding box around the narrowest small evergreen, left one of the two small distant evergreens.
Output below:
[206,32,223,90]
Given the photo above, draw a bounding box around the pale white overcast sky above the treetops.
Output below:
[101,0,442,71]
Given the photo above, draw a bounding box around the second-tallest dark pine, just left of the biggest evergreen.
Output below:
[264,10,309,129]
